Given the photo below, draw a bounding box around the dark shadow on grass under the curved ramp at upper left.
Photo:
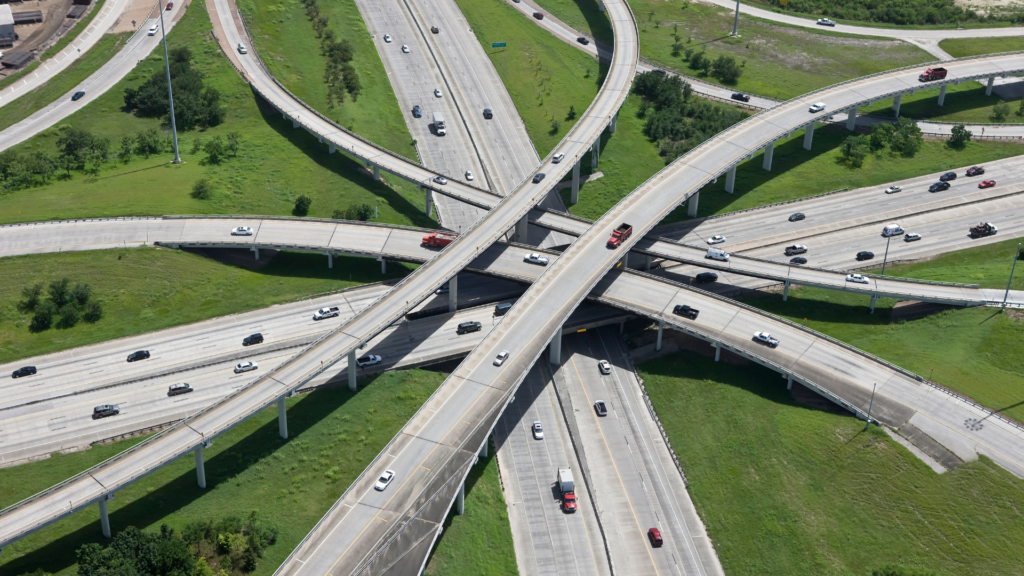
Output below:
[253,92,437,229]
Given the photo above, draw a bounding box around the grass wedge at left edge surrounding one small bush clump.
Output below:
[0,248,412,364]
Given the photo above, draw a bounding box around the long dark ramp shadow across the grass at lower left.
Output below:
[2,377,368,576]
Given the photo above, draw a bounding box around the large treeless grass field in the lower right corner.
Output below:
[638,353,1024,576]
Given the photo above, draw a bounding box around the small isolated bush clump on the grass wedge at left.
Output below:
[17,278,103,332]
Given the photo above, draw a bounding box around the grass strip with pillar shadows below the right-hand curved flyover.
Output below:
[665,124,1024,222]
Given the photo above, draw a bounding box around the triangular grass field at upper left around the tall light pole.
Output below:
[0,0,436,227]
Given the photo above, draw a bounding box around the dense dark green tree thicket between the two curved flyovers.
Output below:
[633,72,748,161]
